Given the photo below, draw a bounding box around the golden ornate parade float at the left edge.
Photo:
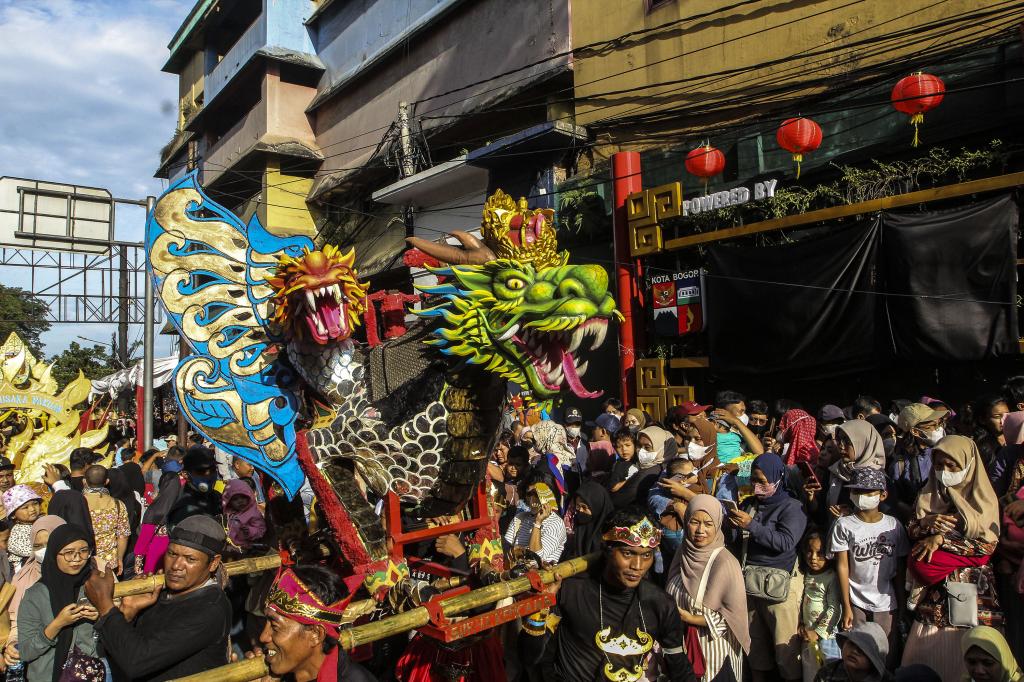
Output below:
[0,332,108,483]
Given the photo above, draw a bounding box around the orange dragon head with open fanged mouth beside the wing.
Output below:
[267,245,370,344]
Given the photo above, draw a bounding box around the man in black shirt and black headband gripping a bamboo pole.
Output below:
[85,515,231,682]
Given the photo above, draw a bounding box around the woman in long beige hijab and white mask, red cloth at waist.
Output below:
[903,435,1002,680]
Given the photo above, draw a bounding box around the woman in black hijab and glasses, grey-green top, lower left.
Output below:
[17,523,101,682]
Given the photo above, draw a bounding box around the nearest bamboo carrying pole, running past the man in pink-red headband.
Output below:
[169,552,600,682]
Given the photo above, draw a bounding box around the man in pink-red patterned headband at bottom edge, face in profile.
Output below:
[256,565,375,682]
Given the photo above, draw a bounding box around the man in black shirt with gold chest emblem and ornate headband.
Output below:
[521,509,696,682]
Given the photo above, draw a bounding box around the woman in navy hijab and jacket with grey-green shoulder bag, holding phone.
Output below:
[729,453,807,682]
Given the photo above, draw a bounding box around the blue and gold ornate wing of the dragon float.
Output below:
[145,172,314,497]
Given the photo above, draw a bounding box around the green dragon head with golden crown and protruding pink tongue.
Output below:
[411,191,622,401]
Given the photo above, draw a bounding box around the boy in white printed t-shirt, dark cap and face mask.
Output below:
[829,468,910,665]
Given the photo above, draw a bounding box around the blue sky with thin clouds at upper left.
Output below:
[0,0,193,356]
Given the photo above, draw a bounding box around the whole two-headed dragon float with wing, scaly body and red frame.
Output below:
[146,173,621,641]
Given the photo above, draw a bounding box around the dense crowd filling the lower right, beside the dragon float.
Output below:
[490,377,1024,682]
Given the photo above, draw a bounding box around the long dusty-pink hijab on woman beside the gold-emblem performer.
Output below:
[666,495,751,653]
